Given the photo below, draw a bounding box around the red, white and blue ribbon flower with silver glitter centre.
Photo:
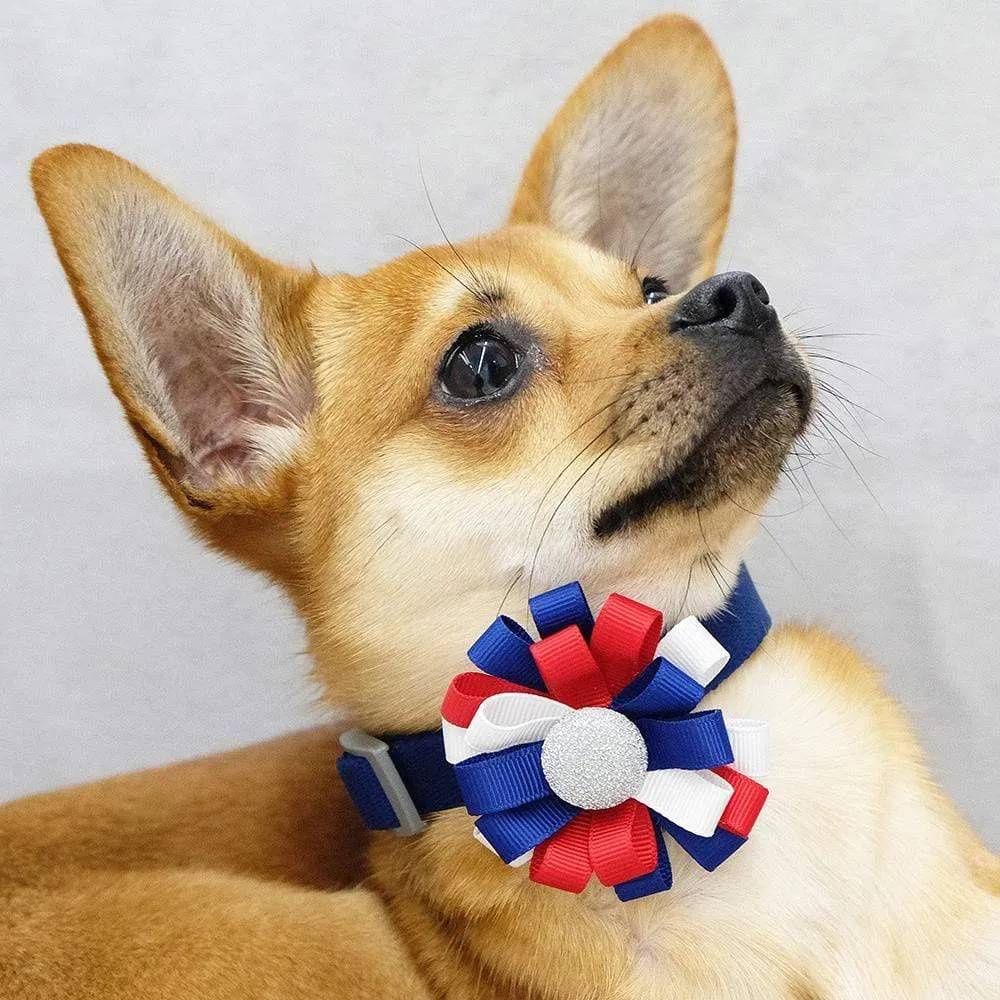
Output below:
[441,583,767,900]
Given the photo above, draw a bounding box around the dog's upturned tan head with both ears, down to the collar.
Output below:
[33,17,811,729]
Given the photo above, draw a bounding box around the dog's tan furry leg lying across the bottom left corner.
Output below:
[0,871,429,1000]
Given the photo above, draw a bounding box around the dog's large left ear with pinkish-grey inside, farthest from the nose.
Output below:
[31,145,315,576]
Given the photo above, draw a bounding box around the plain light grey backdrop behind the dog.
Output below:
[0,0,1000,846]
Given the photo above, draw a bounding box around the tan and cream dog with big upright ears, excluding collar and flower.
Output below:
[0,17,1000,1000]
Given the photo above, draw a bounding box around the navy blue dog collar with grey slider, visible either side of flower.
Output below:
[337,566,771,834]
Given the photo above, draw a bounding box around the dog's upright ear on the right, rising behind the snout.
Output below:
[510,15,736,292]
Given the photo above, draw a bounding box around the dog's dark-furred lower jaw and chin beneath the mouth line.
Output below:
[593,379,810,538]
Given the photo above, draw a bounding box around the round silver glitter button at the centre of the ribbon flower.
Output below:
[542,708,648,809]
